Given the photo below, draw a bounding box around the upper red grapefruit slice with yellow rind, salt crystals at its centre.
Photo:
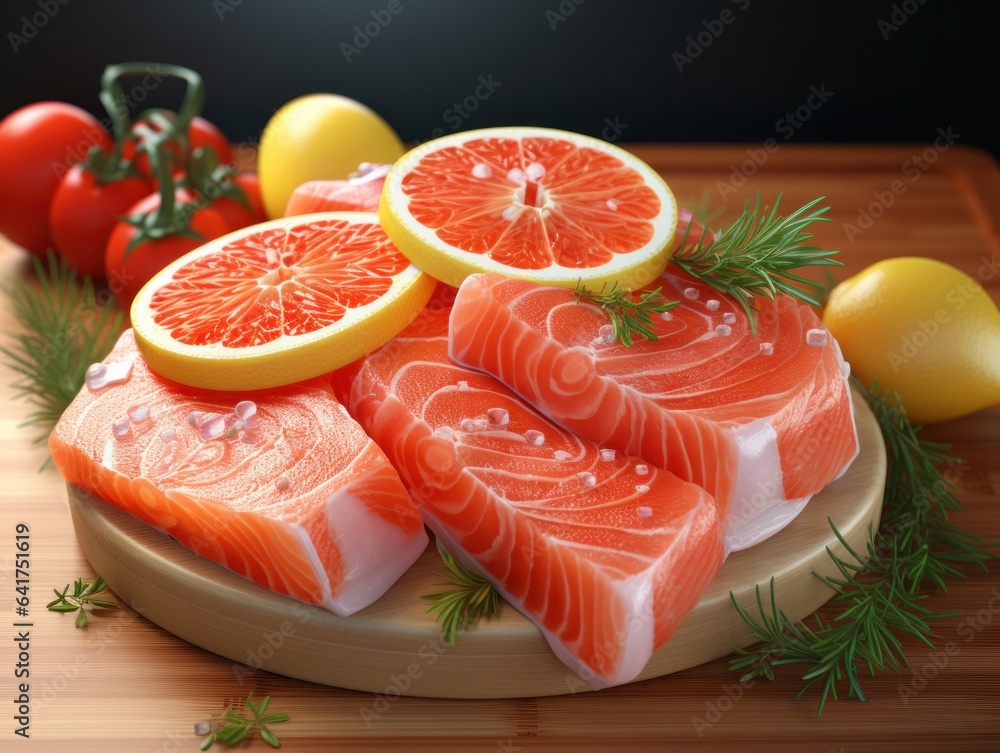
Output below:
[379,128,677,289]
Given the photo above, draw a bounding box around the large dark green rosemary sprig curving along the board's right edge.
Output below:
[730,383,997,716]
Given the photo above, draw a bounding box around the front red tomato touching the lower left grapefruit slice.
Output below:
[104,188,229,311]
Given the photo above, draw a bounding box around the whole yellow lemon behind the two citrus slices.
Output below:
[257,94,406,217]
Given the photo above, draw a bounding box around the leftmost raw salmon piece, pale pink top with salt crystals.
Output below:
[49,330,427,615]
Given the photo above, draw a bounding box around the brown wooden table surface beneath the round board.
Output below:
[0,145,1000,753]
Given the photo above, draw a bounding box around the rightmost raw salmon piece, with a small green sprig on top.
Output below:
[450,267,858,551]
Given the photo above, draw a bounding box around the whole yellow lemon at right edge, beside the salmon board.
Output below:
[823,257,1000,424]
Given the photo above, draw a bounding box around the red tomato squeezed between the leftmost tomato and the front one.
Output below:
[49,165,152,277]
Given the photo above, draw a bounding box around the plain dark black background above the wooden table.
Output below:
[0,0,1000,155]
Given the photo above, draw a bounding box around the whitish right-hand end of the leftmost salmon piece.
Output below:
[296,490,428,617]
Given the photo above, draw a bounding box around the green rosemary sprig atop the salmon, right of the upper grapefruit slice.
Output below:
[670,193,840,333]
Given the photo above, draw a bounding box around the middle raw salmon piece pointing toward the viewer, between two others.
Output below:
[334,308,722,688]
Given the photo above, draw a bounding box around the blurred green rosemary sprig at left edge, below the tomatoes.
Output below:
[0,251,122,458]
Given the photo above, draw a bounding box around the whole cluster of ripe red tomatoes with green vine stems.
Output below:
[0,64,265,307]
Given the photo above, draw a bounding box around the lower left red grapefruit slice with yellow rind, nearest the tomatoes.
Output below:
[132,212,435,390]
